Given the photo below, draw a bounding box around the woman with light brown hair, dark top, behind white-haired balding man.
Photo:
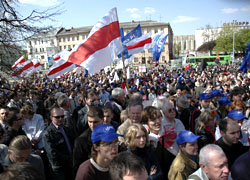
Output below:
[197,110,217,149]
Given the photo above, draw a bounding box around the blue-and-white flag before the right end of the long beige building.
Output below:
[152,34,168,62]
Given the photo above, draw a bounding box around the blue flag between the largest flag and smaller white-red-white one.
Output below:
[118,24,142,59]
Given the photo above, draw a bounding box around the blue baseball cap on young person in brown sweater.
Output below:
[91,124,122,144]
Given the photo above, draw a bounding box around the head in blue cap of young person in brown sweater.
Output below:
[91,124,121,166]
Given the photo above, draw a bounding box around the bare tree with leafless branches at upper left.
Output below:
[0,0,63,71]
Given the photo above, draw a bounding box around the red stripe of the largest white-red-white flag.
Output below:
[68,21,120,65]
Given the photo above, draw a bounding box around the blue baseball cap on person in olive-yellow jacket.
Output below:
[176,131,200,146]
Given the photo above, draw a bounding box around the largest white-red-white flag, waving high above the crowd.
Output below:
[68,8,123,74]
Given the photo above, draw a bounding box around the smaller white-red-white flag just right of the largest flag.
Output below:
[126,33,152,55]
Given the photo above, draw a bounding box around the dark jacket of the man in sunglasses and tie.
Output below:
[42,123,75,171]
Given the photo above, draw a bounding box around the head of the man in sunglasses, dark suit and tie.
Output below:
[50,106,65,126]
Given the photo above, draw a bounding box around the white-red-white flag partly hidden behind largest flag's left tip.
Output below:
[48,51,76,79]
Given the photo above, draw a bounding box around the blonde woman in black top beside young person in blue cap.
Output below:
[125,124,162,179]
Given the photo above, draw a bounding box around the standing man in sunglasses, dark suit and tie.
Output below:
[43,106,75,180]
